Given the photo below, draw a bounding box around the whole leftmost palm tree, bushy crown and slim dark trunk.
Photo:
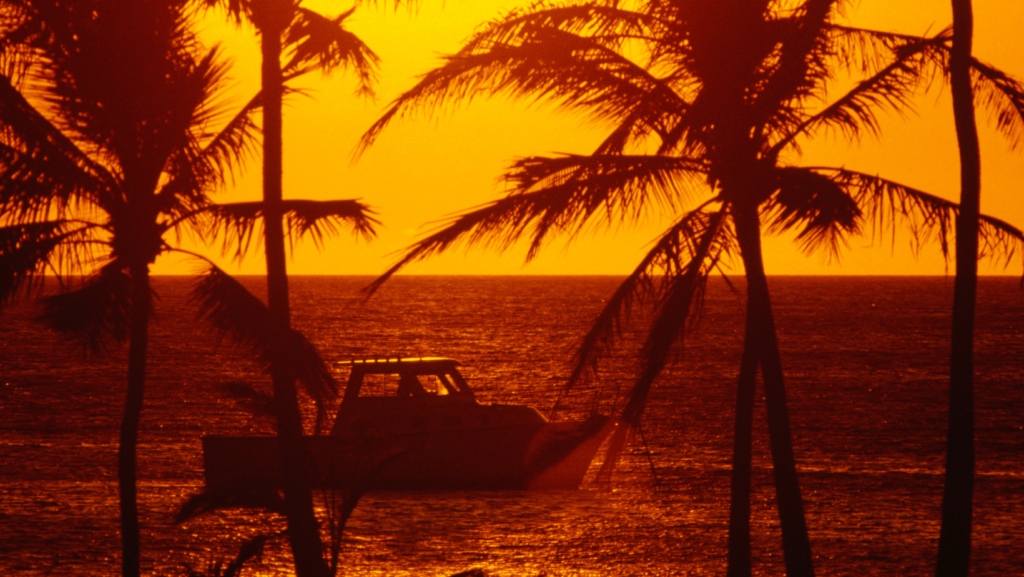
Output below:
[0,0,255,576]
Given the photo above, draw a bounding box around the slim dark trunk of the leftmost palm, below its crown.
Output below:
[118,263,150,577]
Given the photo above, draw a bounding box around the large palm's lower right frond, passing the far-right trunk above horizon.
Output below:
[809,167,1024,266]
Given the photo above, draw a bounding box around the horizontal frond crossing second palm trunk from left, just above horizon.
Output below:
[206,200,380,258]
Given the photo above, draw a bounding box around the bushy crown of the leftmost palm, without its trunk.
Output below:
[0,0,254,298]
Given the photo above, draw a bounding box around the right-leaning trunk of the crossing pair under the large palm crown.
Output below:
[733,205,814,577]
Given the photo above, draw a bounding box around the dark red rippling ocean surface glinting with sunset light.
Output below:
[0,277,1024,577]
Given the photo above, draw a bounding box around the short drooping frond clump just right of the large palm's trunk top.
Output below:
[761,167,860,259]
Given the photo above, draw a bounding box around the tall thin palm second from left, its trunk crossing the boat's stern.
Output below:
[196,0,377,577]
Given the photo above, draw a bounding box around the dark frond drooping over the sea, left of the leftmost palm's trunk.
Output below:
[38,261,135,355]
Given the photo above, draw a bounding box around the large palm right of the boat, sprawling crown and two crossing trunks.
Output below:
[360,0,1024,575]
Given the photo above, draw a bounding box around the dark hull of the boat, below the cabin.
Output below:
[203,421,608,490]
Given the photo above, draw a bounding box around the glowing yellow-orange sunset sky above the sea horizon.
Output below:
[154,0,1024,275]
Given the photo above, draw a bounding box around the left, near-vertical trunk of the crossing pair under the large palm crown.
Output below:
[726,330,758,577]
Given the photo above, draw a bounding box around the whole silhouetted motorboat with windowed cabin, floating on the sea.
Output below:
[203,357,613,490]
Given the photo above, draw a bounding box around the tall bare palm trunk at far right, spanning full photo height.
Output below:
[935,0,981,577]
